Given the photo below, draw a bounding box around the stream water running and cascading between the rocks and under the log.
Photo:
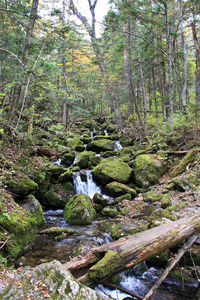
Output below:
[15,132,198,300]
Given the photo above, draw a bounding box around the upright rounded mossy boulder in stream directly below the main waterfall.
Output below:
[63,194,96,225]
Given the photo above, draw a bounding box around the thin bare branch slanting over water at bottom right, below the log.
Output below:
[142,235,198,300]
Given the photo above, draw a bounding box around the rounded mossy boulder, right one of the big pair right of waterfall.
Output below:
[132,154,167,189]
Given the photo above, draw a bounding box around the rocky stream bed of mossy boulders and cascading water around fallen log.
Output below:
[0,121,200,300]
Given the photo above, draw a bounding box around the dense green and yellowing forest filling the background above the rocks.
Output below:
[0,0,200,136]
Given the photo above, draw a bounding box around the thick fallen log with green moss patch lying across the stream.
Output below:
[65,213,200,286]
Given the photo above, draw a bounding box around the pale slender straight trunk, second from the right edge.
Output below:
[178,0,187,113]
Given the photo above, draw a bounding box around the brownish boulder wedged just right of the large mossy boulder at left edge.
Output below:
[18,195,45,226]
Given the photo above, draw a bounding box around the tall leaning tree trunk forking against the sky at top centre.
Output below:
[70,0,123,129]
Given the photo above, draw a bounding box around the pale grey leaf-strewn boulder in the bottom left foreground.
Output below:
[0,260,109,300]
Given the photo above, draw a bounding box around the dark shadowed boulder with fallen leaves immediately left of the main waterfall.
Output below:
[44,181,75,208]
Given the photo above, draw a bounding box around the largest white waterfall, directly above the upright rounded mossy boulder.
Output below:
[73,170,101,198]
